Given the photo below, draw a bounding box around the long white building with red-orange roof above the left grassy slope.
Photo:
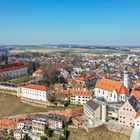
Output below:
[21,84,52,102]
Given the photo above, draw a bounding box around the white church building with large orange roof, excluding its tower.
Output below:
[94,78,129,102]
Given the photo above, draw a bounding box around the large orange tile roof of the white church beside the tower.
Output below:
[96,78,128,94]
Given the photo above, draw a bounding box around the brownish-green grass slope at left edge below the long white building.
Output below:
[0,93,47,118]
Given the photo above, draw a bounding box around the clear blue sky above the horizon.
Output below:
[0,0,140,46]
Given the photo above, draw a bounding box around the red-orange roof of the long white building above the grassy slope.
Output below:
[24,84,51,91]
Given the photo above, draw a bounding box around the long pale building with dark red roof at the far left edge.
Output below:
[0,63,27,79]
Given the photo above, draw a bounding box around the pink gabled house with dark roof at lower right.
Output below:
[118,95,140,126]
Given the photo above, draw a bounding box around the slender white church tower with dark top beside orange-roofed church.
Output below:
[123,67,130,89]
